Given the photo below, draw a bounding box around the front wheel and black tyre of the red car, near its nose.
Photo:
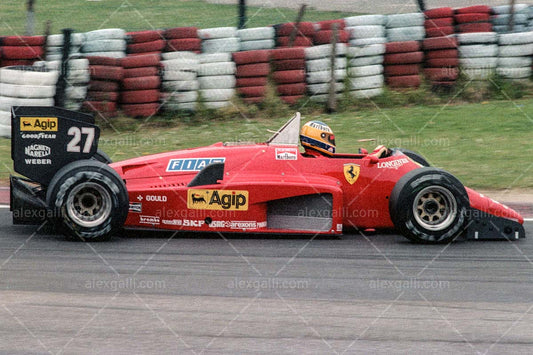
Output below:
[389,167,470,244]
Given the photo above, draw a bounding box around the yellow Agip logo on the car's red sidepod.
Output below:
[187,189,248,211]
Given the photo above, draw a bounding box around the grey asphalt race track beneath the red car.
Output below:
[0,209,533,354]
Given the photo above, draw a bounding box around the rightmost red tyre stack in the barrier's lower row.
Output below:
[423,36,459,88]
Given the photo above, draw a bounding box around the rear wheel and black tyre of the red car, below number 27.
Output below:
[46,160,129,242]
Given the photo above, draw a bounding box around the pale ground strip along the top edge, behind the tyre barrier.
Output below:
[207,0,533,14]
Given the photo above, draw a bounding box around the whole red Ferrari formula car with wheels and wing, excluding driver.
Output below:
[11,107,525,243]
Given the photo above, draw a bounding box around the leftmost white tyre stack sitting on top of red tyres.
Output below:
[81,28,126,58]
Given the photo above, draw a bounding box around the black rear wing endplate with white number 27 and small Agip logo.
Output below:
[11,106,100,186]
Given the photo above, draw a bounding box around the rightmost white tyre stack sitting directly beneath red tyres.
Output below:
[457,32,498,80]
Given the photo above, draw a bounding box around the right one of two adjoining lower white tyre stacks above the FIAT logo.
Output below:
[198,53,236,109]
